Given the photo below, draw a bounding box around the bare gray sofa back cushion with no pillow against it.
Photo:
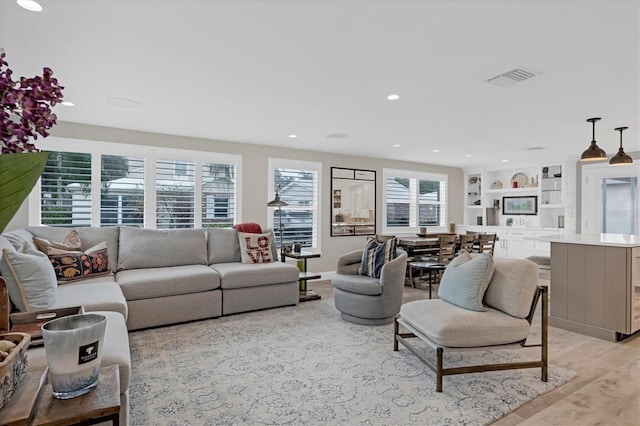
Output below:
[118,226,207,271]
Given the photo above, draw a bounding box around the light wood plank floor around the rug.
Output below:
[305,281,640,426]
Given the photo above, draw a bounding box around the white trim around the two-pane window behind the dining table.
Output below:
[382,169,450,234]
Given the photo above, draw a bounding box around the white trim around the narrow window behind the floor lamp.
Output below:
[265,157,322,252]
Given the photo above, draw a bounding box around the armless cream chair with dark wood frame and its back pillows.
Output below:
[393,251,548,392]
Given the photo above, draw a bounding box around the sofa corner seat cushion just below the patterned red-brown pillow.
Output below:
[51,275,128,319]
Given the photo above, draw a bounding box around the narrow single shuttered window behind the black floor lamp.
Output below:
[269,158,321,248]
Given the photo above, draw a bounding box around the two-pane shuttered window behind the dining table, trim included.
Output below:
[383,169,447,232]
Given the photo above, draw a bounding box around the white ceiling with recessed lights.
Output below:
[0,0,640,167]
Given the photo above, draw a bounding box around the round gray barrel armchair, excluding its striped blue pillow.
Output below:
[331,249,407,325]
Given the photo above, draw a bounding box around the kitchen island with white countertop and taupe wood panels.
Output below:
[537,234,640,341]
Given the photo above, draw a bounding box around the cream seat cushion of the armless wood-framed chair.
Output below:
[400,299,530,348]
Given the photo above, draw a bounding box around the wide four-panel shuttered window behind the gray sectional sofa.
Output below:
[35,137,241,229]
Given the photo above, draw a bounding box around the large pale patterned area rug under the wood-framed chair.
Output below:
[129,299,575,425]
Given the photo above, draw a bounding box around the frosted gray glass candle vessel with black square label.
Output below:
[42,313,107,399]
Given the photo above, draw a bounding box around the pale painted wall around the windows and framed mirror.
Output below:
[7,122,464,272]
